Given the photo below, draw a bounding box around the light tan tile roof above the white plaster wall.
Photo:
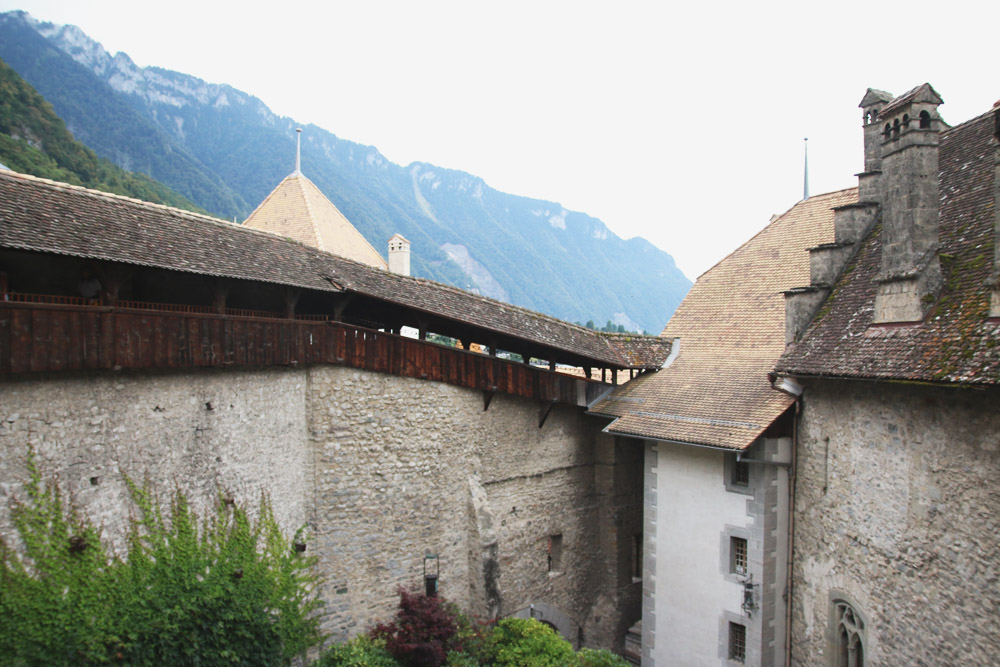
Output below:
[591,188,857,449]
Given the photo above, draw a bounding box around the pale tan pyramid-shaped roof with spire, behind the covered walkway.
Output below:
[243,172,388,269]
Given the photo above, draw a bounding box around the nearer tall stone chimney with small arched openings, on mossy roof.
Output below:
[865,83,947,324]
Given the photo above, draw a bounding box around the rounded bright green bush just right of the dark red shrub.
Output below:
[484,618,578,667]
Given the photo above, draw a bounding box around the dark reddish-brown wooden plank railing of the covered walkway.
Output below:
[0,297,607,405]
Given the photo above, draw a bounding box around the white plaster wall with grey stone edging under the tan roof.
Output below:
[653,443,750,667]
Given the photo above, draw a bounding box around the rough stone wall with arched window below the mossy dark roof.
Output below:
[792,382,1000,665]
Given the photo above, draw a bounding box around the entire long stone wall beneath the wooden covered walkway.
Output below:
[0,366,642,647]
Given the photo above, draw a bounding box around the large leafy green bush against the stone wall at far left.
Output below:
[0,452,320,665]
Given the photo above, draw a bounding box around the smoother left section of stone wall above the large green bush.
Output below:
[0,369,312,545]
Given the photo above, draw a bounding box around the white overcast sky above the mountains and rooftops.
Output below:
[0,0,1000,279]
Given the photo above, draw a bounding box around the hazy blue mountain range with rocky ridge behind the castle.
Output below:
[0,11,691,333]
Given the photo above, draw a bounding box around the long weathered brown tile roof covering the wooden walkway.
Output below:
[0,171,670,368]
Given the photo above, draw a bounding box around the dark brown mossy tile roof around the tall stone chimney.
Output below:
[777,113,1000,385]
